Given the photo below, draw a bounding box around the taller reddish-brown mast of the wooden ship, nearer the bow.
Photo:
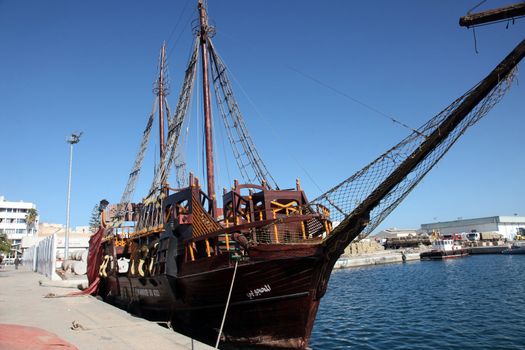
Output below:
[199,0,217,215]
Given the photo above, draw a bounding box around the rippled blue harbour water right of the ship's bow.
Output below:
[310,255,525,350]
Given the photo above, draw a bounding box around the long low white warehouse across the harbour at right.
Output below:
[421,216,525,240]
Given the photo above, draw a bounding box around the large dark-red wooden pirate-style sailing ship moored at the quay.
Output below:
[88,0,525,349]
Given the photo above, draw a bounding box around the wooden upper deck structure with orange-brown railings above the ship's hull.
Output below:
[101,175,332,284]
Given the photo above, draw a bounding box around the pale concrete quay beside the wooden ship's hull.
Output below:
[0,267,212,350]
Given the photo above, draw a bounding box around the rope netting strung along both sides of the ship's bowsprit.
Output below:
[311,71,514,238]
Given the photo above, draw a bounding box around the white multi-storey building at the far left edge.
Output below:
[0,196,38,251]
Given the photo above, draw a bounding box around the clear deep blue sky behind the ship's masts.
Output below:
[0,0,525,232]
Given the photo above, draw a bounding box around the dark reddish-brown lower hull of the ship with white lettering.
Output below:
[99,247,326,349]
